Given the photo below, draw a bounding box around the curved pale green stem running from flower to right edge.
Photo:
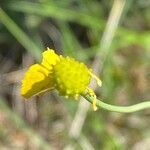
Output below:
[82,95,150,113]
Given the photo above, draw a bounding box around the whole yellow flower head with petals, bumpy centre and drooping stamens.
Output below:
[21,48,101,110]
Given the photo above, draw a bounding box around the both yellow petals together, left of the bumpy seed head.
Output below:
[21,49,59,98]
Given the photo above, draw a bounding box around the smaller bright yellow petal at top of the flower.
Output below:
[41,48,59,71]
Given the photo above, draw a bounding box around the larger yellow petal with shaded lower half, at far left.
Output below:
[21,64,54,98]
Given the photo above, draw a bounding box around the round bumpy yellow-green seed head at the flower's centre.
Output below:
[54,57,91,98]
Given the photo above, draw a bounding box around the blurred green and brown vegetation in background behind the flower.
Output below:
[0,0,150,150]
